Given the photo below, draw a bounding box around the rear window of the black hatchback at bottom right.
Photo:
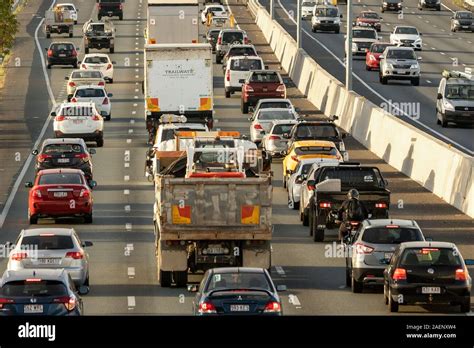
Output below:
[400,248,462,267]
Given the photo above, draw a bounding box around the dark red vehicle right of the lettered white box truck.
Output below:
[241,70,286,114]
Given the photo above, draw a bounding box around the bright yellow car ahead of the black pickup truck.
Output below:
[283,140,343,188]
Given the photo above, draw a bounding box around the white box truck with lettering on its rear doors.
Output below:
[143,43,214,139]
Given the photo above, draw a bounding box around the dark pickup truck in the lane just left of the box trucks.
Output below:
[82,19,115,54]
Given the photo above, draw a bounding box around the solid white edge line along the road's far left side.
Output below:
[0,0,56,228]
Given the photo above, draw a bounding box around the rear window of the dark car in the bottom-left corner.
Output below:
[0,279,68,297]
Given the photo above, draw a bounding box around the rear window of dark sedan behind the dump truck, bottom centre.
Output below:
[207,272,273,291]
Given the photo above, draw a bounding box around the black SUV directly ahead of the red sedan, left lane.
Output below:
[32,138,95,181]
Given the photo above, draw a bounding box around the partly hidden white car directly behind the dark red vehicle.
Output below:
[249,109,298,143]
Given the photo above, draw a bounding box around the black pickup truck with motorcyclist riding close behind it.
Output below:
[306,162,390,242]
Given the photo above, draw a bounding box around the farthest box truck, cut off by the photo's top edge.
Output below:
[146,0,199,44]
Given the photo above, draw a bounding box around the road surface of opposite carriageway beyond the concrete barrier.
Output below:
[262,0,474,155]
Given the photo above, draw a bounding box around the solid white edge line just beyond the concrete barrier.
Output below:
[277,0,474,155]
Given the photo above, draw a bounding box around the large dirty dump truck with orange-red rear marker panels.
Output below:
[153,142,273,287]
